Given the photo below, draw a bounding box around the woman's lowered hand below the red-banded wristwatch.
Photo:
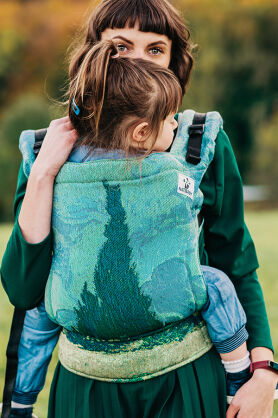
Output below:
[226,369,278,418]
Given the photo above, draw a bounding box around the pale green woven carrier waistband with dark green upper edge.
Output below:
[59,321,212,383]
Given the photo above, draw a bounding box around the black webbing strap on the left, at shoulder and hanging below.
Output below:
[1,129,47,418]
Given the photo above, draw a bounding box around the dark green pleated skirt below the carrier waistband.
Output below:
[48,348,226,418]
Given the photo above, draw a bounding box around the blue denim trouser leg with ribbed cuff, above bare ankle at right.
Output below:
[201,266,248,353]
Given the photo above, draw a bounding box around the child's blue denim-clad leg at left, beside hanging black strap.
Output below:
[12,303,60,412]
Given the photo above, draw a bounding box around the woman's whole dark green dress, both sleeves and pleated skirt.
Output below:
[1,129,273,418]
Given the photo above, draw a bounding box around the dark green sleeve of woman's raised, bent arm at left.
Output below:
[1,164,53,309]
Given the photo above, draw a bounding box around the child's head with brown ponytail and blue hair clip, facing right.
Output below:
[69,41,182,156]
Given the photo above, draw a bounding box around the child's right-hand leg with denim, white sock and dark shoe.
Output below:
[201,266,251,402]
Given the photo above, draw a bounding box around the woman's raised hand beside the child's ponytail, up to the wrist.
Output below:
[33,116,78,178]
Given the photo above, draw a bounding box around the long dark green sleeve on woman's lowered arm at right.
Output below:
[200,129,273,351]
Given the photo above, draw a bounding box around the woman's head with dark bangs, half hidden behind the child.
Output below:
[70,0,193,94]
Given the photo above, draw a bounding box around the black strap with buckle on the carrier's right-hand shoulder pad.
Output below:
[186,112,207,165]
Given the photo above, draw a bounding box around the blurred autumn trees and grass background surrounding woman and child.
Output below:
[0,0,278,418]
